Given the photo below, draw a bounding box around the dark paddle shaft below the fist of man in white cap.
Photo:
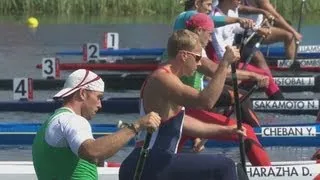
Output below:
[133,132,152,180]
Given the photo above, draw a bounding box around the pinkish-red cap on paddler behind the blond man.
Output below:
[186,13,214,31]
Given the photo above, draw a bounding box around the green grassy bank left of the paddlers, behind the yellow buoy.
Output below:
[0,0,182,16]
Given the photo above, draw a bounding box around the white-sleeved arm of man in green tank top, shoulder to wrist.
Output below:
[59,113,143,163]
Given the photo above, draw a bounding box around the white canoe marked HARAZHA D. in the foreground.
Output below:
[0,161,320,180]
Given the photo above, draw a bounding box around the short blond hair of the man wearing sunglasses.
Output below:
[167,29,200,58]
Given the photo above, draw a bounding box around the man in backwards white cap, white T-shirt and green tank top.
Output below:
[32,69,160,180]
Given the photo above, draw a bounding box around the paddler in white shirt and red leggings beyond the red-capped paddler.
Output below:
[212,0,284,100]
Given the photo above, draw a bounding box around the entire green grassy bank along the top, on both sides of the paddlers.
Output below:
[0,0,320,20]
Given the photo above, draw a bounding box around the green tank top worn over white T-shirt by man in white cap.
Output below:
[32,108,98,180]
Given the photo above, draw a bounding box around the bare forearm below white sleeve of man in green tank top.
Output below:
[78,128,135,164]
